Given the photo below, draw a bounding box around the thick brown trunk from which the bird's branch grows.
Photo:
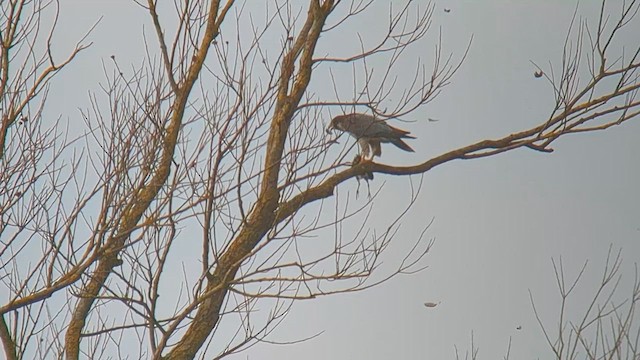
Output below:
[160,0,333,360]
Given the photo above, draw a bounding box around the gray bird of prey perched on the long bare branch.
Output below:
[327,113,415,160]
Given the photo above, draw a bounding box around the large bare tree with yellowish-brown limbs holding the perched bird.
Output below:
[0,0,640,359]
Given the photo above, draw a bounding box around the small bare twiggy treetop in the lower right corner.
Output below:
[530,248,640,359]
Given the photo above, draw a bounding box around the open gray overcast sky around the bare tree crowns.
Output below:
[49,0,640,359]
